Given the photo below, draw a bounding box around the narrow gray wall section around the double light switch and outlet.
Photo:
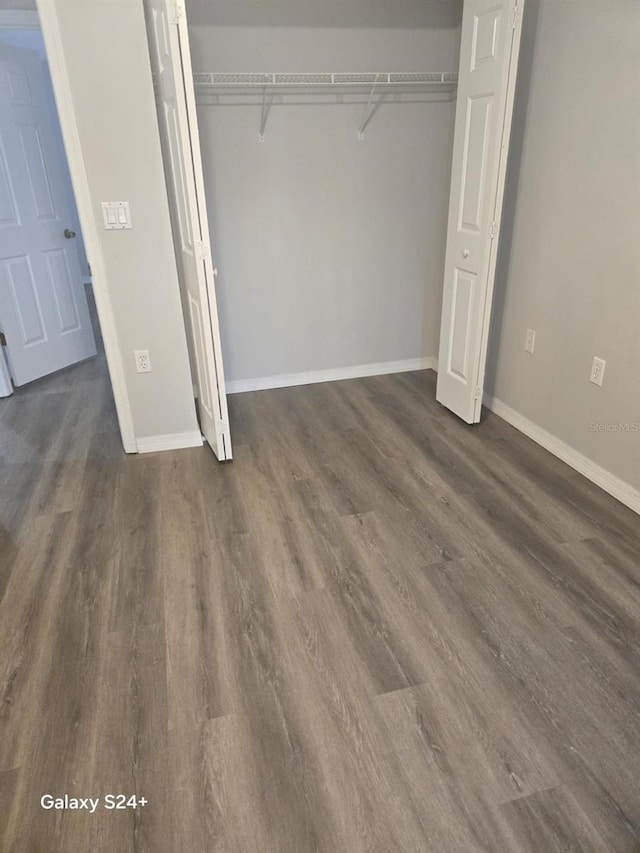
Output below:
[54,0,197,438]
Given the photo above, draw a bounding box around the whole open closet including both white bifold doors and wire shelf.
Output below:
[145,0,522,459]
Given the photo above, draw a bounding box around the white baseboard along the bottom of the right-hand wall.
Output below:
[484,394,640,514]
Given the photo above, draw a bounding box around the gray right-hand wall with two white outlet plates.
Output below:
[487,0,640,488]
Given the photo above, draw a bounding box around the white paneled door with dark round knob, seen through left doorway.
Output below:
[0,45,96,385]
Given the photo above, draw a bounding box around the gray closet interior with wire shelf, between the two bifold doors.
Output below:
[186,0,462,393]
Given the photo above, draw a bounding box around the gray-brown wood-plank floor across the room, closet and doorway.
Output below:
[0,359,640,853]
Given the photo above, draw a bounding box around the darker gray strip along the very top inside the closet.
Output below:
[187,0,462,28]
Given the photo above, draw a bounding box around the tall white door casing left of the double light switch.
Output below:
[38,0,138,453]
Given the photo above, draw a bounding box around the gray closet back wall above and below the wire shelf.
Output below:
[190,25,459,391]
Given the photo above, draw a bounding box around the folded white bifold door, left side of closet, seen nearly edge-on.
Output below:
[144,0,231,462]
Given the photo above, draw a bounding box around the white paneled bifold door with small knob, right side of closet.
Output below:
[436,0,524,423]
